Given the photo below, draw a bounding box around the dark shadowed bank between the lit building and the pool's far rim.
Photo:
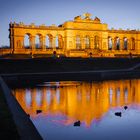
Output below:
[0,58,140,74]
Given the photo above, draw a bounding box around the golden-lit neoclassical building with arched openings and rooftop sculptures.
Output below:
[1,13,140,57]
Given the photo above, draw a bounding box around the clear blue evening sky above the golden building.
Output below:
[0,0,140,46]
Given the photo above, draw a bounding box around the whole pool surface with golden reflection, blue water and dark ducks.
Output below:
[12,79,140,140]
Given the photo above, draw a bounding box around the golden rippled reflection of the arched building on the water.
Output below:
[13,80,140,126]
